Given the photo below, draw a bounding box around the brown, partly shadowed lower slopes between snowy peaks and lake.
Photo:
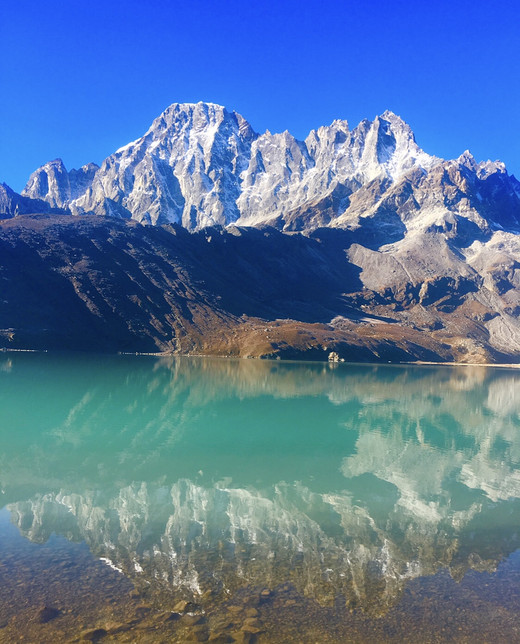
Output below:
[0,215,520,361]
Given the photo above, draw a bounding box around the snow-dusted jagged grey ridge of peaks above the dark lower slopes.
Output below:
[23,103,520,231]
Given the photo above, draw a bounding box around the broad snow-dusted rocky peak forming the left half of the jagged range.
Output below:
[24,103,255,229]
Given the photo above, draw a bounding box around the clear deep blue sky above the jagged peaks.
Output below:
[0,0,520,190]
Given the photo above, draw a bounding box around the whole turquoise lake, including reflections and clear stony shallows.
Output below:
[0,353,520,643]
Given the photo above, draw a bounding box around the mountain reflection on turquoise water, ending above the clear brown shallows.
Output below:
[0,354,520,615]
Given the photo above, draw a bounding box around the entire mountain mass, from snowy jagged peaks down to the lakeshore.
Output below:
[0,103,520,362]
